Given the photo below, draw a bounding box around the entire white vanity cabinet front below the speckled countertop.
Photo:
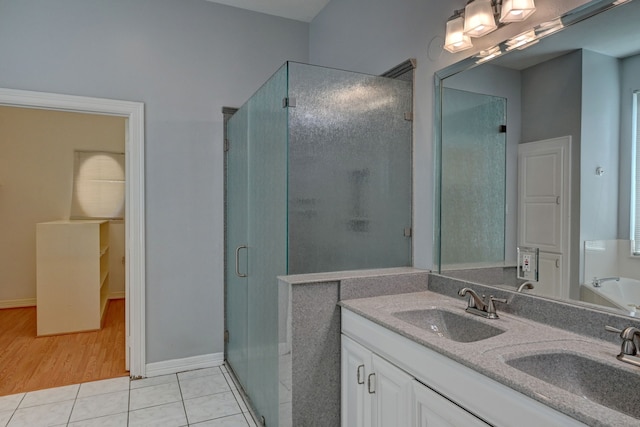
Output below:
[341,307,584,427]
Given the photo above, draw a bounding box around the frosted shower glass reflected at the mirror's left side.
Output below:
[440,88,506,269]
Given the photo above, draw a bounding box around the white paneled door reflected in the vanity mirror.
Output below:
[518,136,571,297]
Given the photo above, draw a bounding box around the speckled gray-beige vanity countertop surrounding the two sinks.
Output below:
[340,291,640,427]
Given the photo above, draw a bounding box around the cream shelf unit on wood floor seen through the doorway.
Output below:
[36,220,109,335]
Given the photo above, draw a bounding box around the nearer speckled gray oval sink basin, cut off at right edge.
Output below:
[506,352,640,418]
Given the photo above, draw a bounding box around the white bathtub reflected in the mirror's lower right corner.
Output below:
[580,277,640,316]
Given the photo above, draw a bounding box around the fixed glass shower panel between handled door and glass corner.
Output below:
[246,66,287,427]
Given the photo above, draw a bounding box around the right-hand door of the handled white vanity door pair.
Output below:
[371,354,413,427]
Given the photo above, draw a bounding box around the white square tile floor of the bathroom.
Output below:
[0,366,256,427]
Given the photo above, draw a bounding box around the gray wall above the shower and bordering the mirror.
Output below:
[309,0,587,268]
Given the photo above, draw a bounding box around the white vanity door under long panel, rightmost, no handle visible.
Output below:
[411,381,490,427]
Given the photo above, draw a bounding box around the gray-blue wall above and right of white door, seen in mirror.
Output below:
[522,50,628,295]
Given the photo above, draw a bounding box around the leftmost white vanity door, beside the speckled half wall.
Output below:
[341,335,371,427]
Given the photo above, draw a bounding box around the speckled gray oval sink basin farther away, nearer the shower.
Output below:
[392,308,504,342]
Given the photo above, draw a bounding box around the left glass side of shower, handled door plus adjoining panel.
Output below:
[226,63,287,427]
